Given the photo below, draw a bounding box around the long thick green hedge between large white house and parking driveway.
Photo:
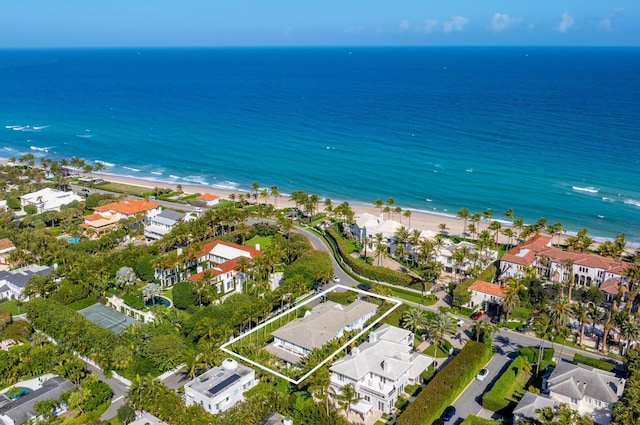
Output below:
[396,341,493,425]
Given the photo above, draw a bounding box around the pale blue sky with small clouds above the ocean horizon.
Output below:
[0,0,640,48]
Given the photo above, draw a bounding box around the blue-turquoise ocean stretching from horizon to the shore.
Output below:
[0,47,640,243]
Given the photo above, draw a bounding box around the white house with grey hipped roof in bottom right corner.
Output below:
[514,362,625,425]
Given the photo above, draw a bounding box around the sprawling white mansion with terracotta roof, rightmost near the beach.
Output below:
[500,235,627,288]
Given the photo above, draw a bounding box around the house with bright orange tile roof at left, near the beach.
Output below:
[81,198,162,233]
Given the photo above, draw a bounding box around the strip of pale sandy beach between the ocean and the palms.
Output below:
[93,174,566,243]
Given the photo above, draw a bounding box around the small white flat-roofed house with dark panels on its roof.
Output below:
[184,359,259,415]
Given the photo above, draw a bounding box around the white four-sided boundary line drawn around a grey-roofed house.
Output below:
[220,284,403,385]
